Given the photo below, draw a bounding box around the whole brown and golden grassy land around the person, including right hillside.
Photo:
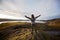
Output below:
[0,19,60,40]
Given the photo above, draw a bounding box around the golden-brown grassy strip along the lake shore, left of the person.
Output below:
[0,22,28,30]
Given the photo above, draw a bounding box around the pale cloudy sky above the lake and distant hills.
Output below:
[0,0,60,20]
